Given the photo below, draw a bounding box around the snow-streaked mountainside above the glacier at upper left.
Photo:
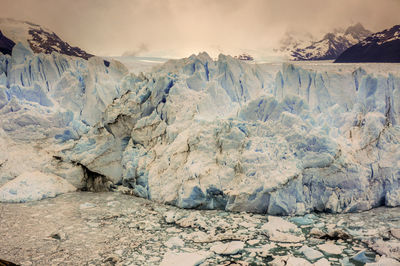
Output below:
[0,18,93,59]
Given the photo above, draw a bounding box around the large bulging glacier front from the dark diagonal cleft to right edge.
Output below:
[60,53,400,215]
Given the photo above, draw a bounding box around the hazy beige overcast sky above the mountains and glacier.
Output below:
[0,0,400,56]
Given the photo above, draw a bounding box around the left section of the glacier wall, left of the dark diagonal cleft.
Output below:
[0,43,128,188]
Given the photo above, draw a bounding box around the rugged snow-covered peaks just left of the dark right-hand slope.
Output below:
[287,23,371,61]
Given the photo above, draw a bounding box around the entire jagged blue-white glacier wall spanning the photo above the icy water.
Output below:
[0,44,400,215]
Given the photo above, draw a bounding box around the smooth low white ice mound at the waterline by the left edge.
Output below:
[0,171,76,202]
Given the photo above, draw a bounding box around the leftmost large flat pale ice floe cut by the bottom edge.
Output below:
[160,251,211,266]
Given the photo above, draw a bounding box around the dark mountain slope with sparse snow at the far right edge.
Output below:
[335,25,400,63]
